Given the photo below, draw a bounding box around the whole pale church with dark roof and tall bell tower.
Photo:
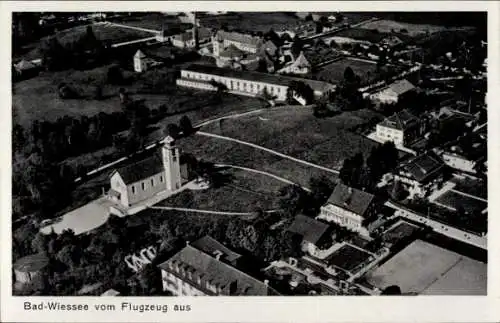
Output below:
[108,136,188,208]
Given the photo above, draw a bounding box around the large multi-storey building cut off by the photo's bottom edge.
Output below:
[159,237,278,296]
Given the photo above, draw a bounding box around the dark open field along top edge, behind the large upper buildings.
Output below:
[200,12,304,33]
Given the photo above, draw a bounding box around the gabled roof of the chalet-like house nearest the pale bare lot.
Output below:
[328,183,375,216]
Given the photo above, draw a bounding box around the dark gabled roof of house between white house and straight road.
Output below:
[398,153,444,183]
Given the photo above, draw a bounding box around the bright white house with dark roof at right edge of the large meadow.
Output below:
[376,110,424,147]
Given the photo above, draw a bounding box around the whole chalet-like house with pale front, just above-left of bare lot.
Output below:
[318,183,378,236]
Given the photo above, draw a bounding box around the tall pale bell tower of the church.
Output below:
[161,136,182,191]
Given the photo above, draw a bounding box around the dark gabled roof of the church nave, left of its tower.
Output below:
[116,150,164,185]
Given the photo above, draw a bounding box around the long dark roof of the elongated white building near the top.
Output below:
[184,64,335,93]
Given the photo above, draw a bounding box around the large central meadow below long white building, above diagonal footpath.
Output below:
[202,107,377,169]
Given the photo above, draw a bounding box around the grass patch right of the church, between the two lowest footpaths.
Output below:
[158,169,285,212]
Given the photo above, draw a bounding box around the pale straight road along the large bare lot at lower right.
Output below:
[385,201,487,249]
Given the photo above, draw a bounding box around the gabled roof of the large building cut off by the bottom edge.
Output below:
[159,245,277,296]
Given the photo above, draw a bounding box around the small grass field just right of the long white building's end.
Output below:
[315,58,397,84]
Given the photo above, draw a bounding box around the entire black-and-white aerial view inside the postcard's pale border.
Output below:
[11,8,488,297]
